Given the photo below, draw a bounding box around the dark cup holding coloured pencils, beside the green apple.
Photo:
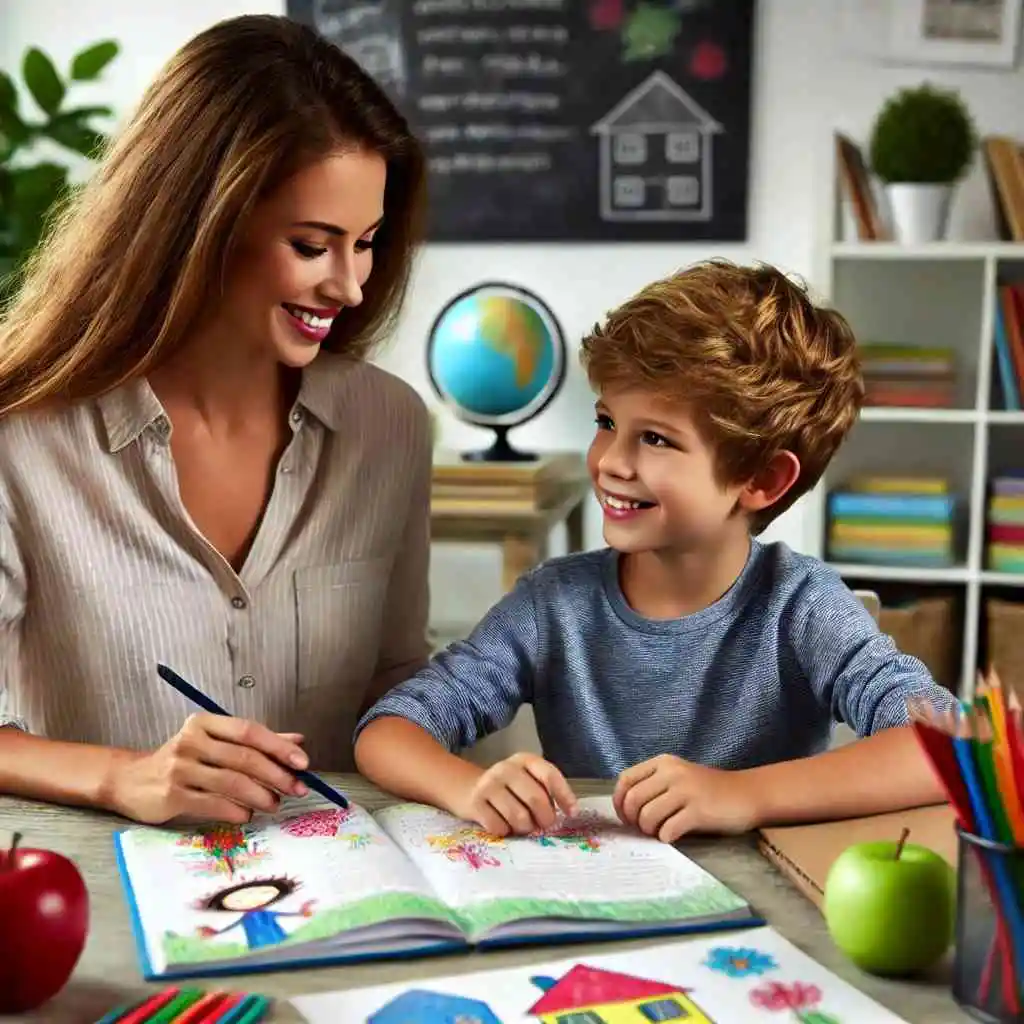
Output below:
[952,825,1024,1024]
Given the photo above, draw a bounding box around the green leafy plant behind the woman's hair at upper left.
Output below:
[0,40,120,299]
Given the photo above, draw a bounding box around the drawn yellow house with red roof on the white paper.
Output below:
[526,964,714,1024]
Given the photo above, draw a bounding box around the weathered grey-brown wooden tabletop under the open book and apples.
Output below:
[0,776,969,1024]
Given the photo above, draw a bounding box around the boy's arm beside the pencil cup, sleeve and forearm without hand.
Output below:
[750,578,956,822]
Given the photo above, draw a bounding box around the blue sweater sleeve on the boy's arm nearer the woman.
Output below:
[353,574,540,752]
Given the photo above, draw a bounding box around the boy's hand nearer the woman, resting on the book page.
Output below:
[452,754,577,836]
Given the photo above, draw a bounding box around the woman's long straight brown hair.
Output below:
[0,15,425,416]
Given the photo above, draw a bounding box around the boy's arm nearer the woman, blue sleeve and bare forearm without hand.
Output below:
[354,577,541,808]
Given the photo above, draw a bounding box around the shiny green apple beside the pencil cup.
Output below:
[822,829,956,977]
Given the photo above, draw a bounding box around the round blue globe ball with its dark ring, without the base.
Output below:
[428,290,563,421]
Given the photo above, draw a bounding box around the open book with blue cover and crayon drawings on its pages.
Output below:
[115,797,763,981]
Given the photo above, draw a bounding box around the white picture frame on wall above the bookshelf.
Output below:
[889,0,1022,68]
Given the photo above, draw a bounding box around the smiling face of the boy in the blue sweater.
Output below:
[587,390,749,554]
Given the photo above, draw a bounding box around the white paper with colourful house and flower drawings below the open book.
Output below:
[292,927,906,1024]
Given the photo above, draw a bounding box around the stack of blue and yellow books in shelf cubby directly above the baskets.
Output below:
[827,476,956,567]
